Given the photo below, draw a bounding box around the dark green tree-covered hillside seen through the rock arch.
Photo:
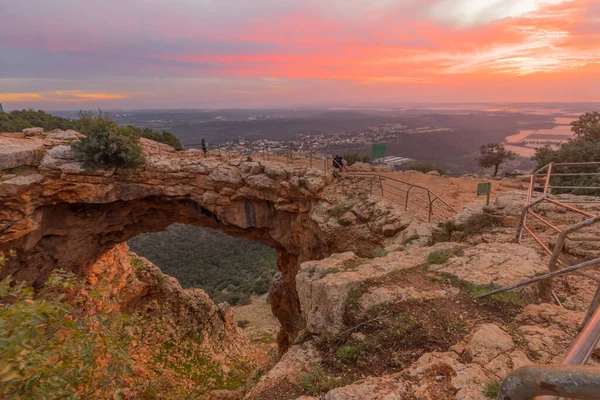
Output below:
[129,224,277,304]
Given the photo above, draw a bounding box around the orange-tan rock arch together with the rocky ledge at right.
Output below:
[0,130,598,400]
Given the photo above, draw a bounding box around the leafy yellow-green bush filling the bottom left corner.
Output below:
[0,272,139,399]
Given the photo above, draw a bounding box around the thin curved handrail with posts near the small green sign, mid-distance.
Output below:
[346,172,458,222]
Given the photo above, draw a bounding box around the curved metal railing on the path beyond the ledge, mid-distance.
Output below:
[339,172,458,222]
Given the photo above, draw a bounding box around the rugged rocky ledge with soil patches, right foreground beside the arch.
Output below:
[245,193,600,400]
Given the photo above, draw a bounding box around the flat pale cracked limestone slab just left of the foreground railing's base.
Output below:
[430,243,547,286]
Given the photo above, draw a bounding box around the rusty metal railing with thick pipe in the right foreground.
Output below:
[490,162,600,400]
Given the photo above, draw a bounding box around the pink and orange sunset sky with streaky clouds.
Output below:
[0,0,600,110]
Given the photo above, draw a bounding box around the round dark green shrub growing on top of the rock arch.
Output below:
[71,112,144,170]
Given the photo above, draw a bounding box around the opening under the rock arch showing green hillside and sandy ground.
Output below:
[127,223,281,343]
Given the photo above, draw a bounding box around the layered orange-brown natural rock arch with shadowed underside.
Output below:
[0,139,410,350]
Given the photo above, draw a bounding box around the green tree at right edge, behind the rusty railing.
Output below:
[532,112,600,196]
